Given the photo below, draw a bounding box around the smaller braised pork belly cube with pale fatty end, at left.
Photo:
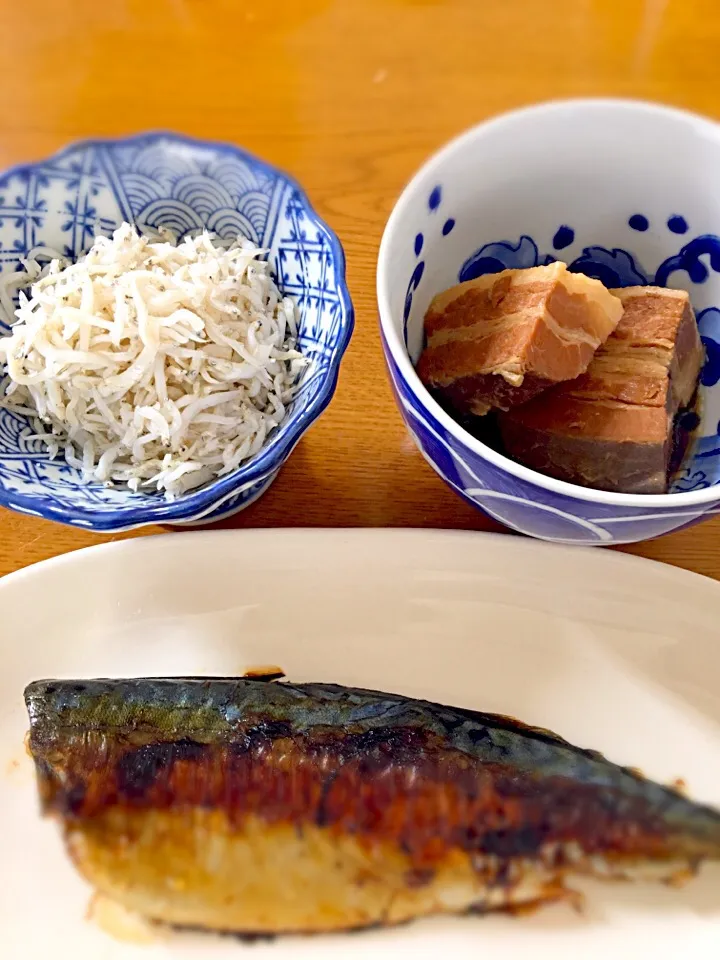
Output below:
[417,262,623,415]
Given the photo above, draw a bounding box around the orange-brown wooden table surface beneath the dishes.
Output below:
[0,0,720,578]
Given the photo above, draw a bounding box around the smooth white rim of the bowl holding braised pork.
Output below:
[376,97,720,509]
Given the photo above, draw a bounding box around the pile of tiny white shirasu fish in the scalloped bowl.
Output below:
[0,223,305,499]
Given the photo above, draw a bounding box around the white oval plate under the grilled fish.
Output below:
[0,530,720,960]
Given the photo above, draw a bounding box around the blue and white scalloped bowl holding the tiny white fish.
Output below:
[0,133,353,532]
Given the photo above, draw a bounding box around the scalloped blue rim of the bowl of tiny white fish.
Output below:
[0,129,355,532]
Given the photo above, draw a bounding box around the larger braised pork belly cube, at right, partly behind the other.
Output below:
[499,287,704,493]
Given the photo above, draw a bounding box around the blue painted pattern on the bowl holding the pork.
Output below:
[394,197,720,544]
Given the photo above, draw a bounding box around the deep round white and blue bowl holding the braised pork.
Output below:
[377,100,720,544]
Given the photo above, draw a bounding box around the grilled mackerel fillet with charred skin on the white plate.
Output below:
[25,678,720,932]
